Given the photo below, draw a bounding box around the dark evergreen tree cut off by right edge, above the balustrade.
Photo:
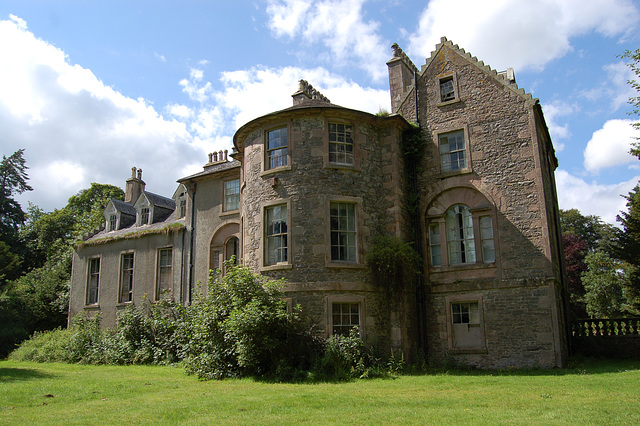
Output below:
[614,184,640,314]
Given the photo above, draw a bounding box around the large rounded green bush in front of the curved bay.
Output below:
[183,264,314,379]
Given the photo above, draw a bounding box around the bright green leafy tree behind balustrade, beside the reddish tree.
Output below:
[582,251,625,318]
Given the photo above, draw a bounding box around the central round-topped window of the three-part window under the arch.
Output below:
[446,204,476,265]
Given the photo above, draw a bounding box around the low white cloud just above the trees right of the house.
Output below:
[556,169,640,224]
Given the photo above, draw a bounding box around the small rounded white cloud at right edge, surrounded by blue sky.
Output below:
[584,120,639,173]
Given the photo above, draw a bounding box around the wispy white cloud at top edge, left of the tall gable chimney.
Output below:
[267,0,390,81]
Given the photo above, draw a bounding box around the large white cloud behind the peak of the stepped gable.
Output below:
[407,0,640,71]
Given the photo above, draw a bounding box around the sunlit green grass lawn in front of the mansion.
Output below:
[0,361,640,425]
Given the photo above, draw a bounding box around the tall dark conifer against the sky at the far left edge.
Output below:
[0,149,32,242]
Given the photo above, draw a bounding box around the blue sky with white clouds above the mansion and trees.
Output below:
[0,0,640,224]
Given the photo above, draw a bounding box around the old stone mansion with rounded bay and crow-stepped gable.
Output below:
[69,38,567,368]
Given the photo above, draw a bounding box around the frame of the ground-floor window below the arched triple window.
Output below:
[444,294,487,354]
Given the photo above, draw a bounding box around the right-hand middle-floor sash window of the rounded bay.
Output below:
[330,202,358,262]
